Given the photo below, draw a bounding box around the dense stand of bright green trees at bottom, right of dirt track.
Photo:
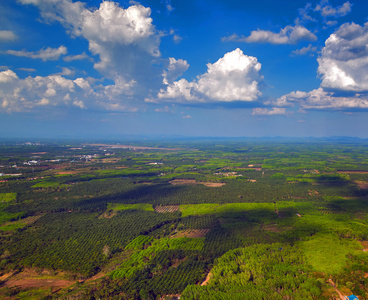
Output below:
[182,244,321,300]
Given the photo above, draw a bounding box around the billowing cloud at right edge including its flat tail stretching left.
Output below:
[276,23,368,110]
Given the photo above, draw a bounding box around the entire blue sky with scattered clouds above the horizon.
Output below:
[0,0,368,138]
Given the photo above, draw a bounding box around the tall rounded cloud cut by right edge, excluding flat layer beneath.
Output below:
[318,23,368,92]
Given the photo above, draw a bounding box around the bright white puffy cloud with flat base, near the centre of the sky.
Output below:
[157,48,263,102]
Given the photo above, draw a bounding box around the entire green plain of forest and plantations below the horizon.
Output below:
[0,139,368,300]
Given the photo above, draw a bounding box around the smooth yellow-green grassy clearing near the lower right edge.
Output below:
[300,234,362,274]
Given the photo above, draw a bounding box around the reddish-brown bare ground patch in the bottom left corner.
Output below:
[3,269,75,289]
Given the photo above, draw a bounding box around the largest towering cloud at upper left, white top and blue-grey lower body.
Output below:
[20,0,163,98]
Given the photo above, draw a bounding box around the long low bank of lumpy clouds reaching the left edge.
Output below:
[0,69,135,113]
